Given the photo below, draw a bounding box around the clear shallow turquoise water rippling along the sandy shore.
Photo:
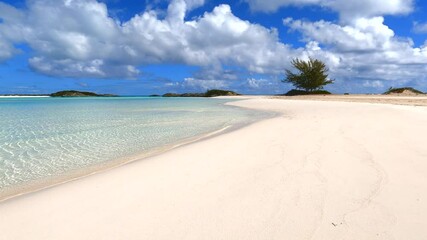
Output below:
[0,97,266,199]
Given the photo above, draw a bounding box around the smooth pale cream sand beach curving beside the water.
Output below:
[0,97,427,240]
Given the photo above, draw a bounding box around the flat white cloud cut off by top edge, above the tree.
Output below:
[245,0,413,20]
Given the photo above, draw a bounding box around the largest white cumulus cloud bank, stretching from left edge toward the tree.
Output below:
[0,0,289,78]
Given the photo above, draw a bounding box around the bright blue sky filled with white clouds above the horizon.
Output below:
[0,0,427,95]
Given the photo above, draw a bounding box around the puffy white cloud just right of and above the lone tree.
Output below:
[283,17,427,86]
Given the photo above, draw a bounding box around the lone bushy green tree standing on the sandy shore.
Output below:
[282,57,334,92]
